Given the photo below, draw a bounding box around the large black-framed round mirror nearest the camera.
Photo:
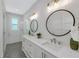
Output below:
[46,9,75,36]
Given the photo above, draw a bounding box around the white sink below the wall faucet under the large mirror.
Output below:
[42,41,63,51]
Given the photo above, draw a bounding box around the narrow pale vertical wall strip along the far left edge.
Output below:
[0,0,3,57]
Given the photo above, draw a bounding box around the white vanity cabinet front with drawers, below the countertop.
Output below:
[22,36,56,58]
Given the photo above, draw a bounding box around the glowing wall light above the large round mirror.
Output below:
[47,0,73,12]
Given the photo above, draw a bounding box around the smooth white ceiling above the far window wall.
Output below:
[4,0,37,14]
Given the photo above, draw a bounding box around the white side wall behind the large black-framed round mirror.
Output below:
[24,0,79,46]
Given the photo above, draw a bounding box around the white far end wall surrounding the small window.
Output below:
[6,12,23,44]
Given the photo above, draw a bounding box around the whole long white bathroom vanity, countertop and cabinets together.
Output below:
[22,35,79,58]
